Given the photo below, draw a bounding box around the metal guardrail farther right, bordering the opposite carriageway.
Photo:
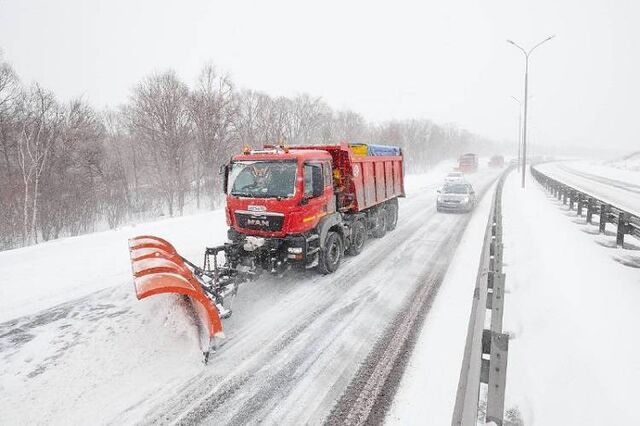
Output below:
[531,166,640,246]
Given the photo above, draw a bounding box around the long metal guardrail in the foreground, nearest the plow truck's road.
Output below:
[451,167,512,426]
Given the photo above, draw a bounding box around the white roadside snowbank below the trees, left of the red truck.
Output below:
[0,210,227,322]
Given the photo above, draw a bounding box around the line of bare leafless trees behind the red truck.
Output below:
[0,57,496,250]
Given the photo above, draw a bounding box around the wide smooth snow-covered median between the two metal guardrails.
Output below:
[503,169,640,426]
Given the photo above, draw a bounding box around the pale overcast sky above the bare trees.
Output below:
[0,0,640,151]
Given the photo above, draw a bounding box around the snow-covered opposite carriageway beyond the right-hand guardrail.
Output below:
[536,161,640,215]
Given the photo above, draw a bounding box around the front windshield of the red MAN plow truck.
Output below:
[229,160,298,198]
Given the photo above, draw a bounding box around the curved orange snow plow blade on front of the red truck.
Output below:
[129,235,224,350]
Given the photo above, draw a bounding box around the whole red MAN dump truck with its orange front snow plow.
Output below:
[129,143,405,362]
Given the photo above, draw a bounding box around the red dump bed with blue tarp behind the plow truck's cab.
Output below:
[296,143,405,213]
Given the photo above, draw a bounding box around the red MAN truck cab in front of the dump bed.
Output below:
[226,149,336,238]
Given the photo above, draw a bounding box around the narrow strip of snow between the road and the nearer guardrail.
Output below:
[385,178,494,425]
